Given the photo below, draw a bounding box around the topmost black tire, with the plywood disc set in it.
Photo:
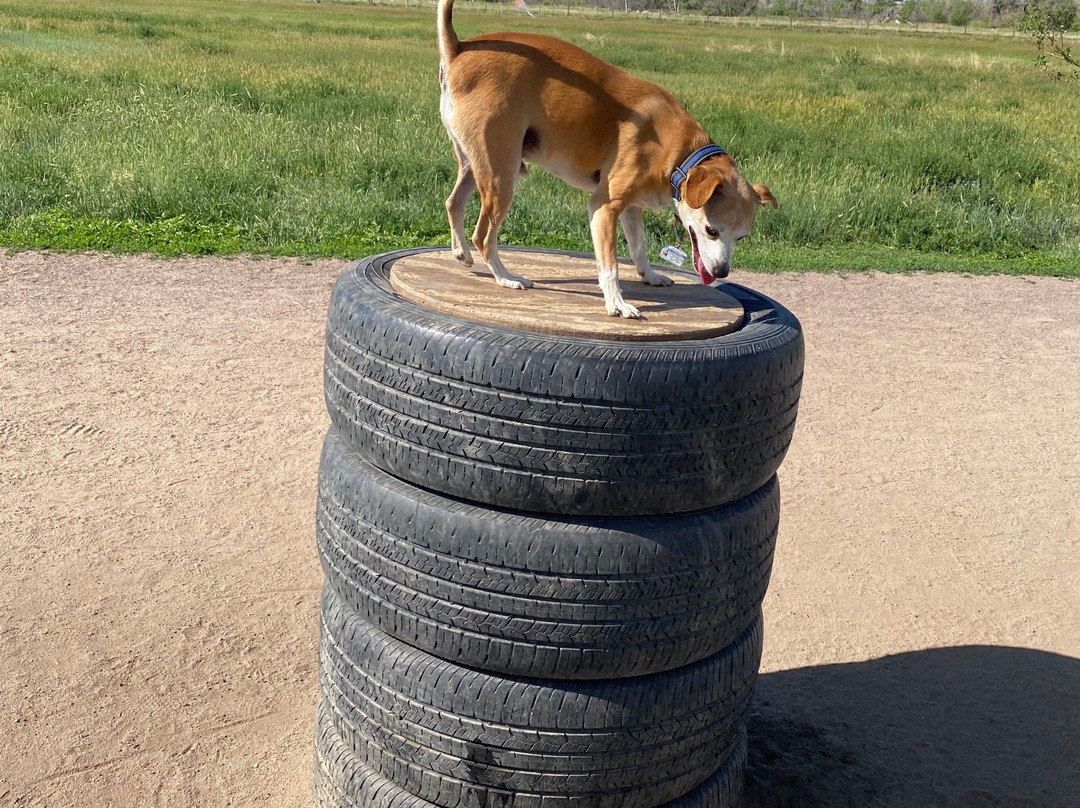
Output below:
[325,244,804,515]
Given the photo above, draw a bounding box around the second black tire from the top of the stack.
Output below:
[315,428,780,679]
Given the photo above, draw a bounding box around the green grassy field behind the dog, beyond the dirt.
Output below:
[0,0,1080,275]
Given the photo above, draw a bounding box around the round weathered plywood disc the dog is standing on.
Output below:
[390,250,743,340]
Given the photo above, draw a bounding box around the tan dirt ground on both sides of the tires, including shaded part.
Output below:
[0,254,1080,808]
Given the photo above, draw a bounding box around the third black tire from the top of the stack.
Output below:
[320,587,761,808]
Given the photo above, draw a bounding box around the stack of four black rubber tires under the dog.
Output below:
[315,251,802,808]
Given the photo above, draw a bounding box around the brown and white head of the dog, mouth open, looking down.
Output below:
[676,154,780,285]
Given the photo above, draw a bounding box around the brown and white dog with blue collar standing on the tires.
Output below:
[438,0,778,318]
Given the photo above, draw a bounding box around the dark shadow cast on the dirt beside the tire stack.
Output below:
[742,646,1080,808]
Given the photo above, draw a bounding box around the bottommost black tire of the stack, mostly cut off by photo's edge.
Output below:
[314,704,746,808]
